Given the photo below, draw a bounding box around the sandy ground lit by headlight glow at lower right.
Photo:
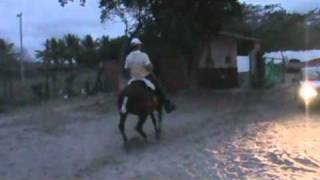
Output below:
[0,88,320,180]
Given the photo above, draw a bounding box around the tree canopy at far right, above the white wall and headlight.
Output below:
[238,4,320,51]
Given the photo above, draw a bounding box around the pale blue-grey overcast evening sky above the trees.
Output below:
[0,0,320,57]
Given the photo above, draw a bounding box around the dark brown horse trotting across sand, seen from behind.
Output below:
[118,80,163,146]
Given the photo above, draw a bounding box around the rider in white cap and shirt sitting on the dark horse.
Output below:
[124,38,176,113]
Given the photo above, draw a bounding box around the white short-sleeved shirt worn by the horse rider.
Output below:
[124,50,151,79]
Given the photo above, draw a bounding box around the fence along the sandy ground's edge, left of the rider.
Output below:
[0,68,103,111]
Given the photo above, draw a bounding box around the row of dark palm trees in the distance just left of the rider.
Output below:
[36,34,124,68]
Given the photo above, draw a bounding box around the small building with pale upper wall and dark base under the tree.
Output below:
[197,32,258,89]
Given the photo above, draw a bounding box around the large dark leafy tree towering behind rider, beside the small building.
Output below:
[58,0,241,75]
